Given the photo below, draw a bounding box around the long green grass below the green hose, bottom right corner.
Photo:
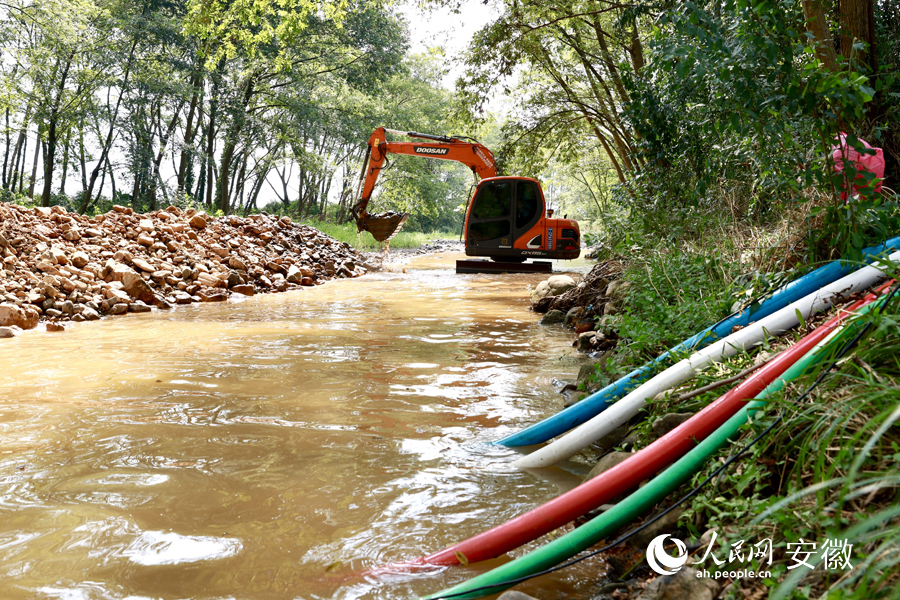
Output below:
[683,284,900,598]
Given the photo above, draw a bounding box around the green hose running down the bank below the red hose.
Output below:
[423,299,883,600]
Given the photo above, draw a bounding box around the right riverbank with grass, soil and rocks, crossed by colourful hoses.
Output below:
[504,247,900,600]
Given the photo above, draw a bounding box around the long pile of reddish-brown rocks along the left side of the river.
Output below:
[0,203,372,337]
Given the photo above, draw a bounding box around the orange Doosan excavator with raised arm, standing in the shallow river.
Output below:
[351,127,581,270]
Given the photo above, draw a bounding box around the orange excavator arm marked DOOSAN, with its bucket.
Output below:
[351,127,497,242]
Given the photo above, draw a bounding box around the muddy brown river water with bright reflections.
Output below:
[0,254,597,600]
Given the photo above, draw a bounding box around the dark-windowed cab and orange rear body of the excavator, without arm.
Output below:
[465,177,581,262]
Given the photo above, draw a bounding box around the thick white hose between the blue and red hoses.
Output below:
[513,252,900,469]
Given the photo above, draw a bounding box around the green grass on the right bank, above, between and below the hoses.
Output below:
[576,215,900,600]
